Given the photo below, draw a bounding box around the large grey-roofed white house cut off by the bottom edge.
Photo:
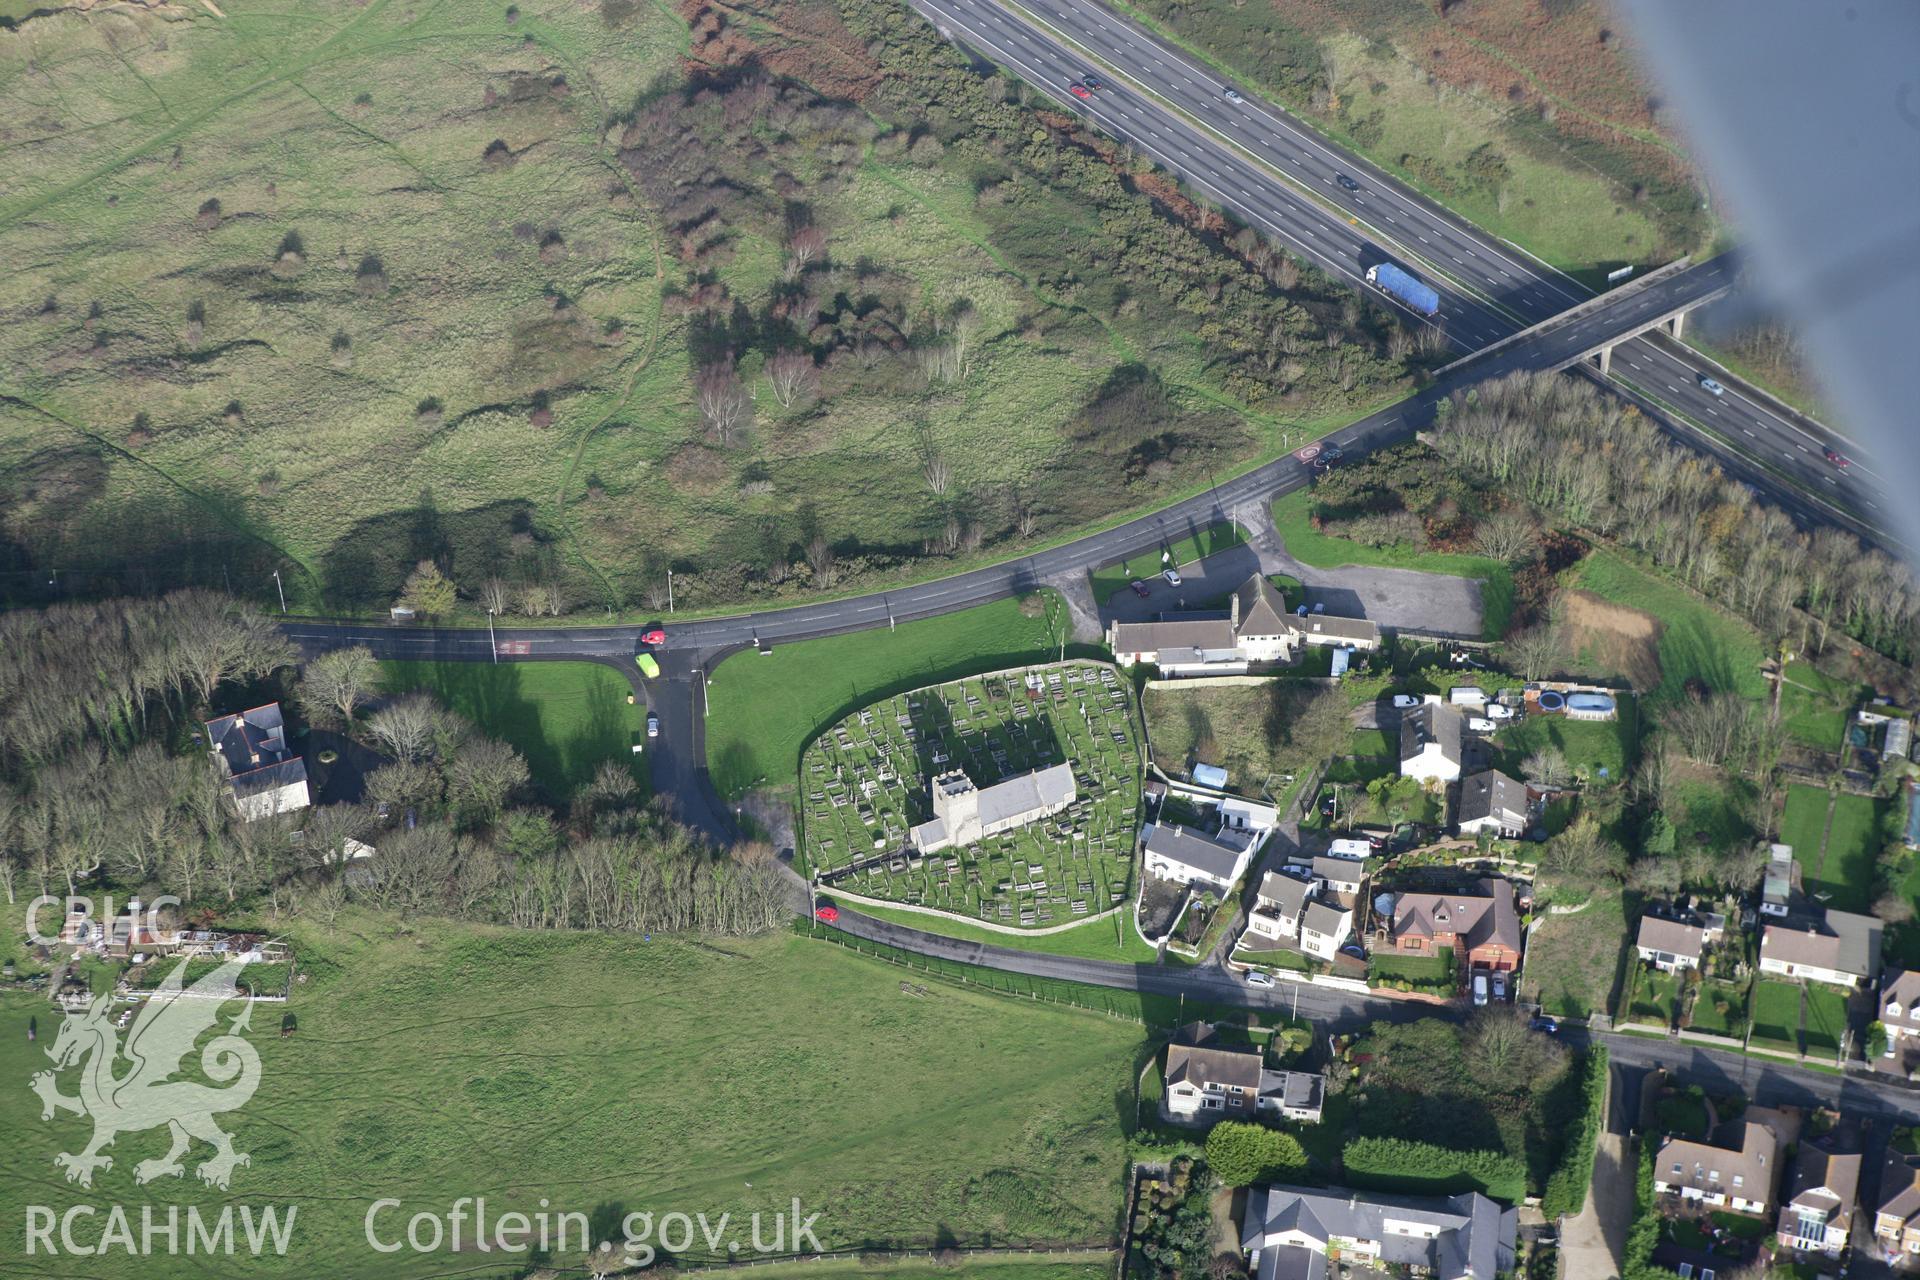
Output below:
[1240,1186,1519,1280]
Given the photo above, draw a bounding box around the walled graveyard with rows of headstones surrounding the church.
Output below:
[801,662,1142,929]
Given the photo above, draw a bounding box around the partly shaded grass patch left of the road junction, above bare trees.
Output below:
[380,662,647,800]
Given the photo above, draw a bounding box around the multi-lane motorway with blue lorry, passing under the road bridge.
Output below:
[910,0,1885,541]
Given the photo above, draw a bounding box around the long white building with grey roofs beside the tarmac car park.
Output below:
[1106,574,1380,676]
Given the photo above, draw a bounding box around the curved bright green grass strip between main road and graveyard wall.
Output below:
[707,593,1058,796]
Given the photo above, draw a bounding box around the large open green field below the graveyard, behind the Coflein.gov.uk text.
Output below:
[0,915,1142,1280]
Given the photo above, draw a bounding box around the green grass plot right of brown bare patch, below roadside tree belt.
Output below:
[1567,551,1766,702]
